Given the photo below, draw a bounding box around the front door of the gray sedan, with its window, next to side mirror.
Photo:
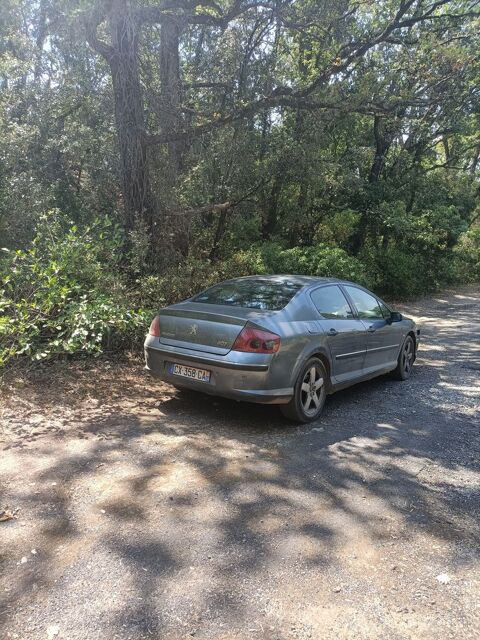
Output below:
[343,285,403,373]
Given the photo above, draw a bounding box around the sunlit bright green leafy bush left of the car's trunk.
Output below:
[0,211,150,365]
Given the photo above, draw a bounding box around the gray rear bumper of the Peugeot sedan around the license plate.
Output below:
[145,344,293,404]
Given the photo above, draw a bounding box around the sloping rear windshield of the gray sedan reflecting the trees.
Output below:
[193,280,302,311]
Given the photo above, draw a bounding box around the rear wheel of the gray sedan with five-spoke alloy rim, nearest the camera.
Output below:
[280,358,328,423]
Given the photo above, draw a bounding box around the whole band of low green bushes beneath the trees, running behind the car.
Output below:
[0,207,480,366]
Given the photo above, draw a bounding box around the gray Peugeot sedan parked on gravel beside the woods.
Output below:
[145,275,420,422]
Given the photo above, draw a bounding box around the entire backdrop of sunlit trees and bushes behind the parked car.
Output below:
[0,0,480,362]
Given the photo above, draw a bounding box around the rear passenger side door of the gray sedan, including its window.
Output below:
[310,284,367,383]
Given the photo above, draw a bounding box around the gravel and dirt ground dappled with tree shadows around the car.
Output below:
[0,287,480,640]
